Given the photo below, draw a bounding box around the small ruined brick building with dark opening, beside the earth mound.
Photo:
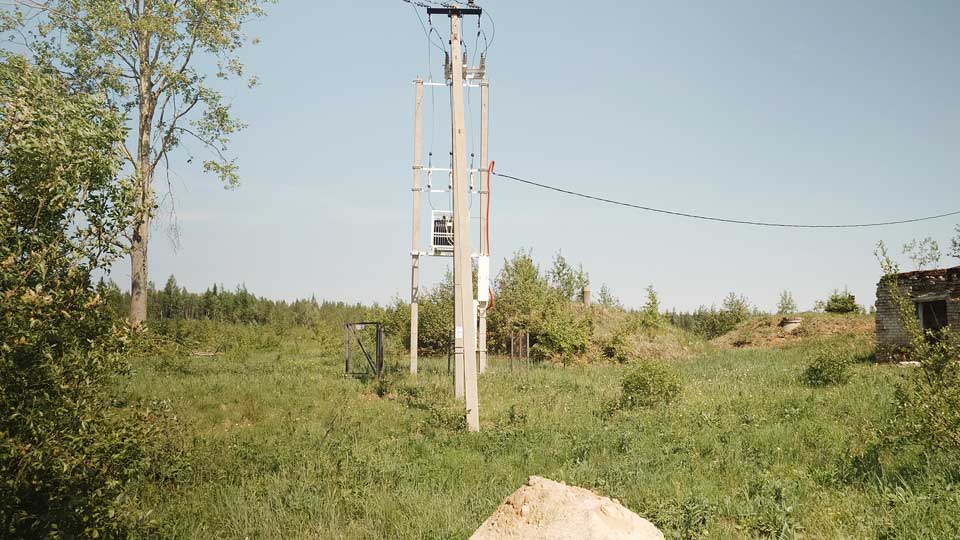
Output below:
[877,266,960,361]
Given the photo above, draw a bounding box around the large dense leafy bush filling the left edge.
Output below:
[0,55,151,538]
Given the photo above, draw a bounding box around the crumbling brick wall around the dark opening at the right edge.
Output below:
[876,266,960,360]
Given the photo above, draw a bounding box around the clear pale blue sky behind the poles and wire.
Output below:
[142,0,960,309]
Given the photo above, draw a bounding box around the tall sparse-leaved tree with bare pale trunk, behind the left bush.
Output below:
[3,0,275,326]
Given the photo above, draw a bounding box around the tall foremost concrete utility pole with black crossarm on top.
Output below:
[427,4,481,431]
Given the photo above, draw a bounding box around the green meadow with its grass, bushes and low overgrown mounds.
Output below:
[71,247,960,538]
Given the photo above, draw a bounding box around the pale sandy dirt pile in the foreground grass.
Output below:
[470,476,663,540]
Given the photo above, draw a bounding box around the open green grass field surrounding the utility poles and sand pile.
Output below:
[129,330,960,539]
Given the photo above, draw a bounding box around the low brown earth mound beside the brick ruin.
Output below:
[712,313,876,348]
